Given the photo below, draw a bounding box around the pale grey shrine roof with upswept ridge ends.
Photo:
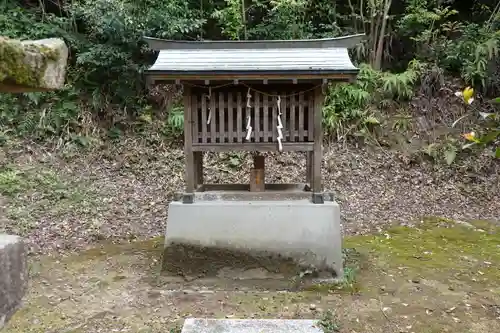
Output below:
[145,34,364,79]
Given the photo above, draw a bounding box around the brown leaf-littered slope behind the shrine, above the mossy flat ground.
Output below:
[0,140,500,253]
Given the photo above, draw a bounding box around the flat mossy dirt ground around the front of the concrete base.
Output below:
[8,219,500,333]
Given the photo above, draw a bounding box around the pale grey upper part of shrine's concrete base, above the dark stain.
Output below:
[165,200,342,278]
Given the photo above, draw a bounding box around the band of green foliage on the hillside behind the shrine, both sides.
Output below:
[0,0,500,154]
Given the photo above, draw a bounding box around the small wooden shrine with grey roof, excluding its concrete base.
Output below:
[146,35,363,203]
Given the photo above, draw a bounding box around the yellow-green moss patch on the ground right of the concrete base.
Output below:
[344,218,500,287]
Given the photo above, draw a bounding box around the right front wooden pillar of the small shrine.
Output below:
[311,87,324,203]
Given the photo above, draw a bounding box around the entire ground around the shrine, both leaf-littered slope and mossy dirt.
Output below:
[0,139,500,333]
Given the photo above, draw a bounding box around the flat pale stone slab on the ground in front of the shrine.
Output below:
[181,318,323,333]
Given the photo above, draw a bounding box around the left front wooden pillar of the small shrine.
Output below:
[183,86,195,203]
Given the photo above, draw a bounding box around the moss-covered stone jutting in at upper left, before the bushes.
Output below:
[0,37,67,91]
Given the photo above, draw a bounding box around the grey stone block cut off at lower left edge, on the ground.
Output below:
[0,234,28,329]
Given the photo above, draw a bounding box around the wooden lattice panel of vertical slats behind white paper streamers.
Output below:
[191,85,314,144]
